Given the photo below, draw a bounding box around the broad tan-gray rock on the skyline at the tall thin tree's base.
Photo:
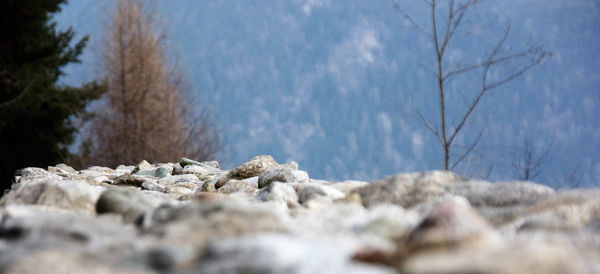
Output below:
[358,171,466,207]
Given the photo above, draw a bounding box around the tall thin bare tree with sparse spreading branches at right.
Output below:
[393,0,551,170]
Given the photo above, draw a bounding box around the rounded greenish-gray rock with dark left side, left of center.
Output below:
[96,188,160,223]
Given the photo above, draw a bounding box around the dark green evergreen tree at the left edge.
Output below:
[0,0,101,193]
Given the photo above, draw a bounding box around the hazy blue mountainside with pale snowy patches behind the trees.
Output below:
[56,0,600,185]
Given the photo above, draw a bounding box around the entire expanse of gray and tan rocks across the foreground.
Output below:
[0,156,600,273]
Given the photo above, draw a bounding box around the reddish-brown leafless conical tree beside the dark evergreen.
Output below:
[87,0,220,166]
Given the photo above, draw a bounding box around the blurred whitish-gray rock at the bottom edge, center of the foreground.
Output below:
[196,234,394,274]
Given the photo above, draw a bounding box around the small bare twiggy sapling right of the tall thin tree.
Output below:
[512,138,552,181]
